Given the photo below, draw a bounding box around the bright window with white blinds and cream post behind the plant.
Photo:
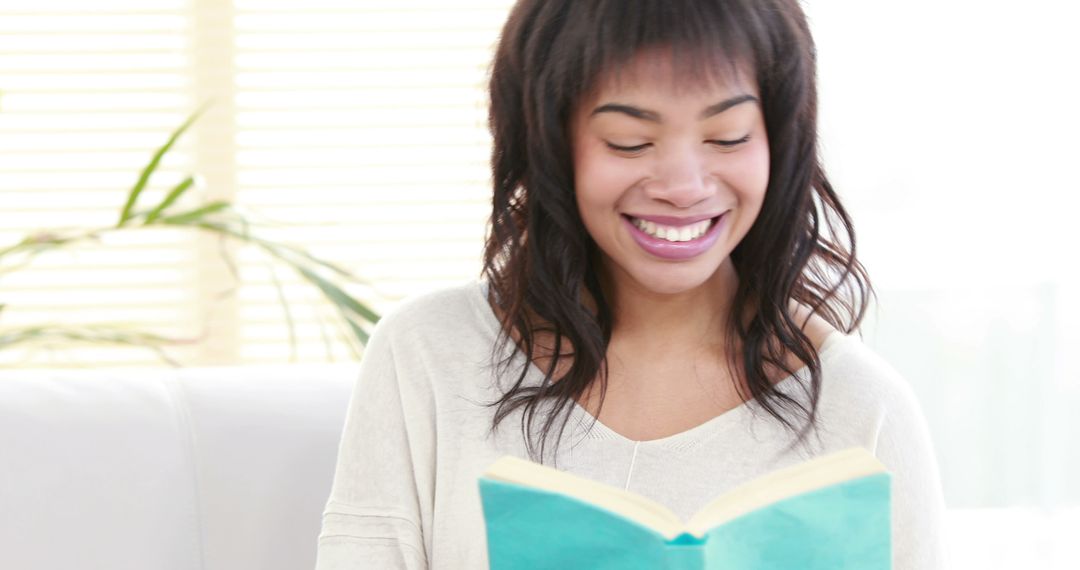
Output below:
[0,0,510,366]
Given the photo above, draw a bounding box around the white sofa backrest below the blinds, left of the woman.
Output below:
[0,363,359,570]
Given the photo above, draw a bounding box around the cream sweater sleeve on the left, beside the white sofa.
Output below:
[315,320,433,570]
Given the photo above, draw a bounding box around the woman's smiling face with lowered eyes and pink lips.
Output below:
[571,53,769,295]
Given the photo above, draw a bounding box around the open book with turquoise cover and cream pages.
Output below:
[480,447,892,570]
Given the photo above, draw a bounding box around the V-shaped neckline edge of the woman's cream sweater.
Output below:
[473,281,848,450]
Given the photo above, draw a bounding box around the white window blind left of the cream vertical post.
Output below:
[0,0,198,365]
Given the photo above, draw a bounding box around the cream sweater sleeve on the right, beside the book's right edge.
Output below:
[877,374,948,570]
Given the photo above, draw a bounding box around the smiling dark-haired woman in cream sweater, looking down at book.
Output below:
[319,0,944,570]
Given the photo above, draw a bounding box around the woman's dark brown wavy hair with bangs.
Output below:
[483,0,876,460]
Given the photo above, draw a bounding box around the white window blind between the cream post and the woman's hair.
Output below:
[226,0,509,359]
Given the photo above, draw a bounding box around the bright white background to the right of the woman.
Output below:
[806,0,1080,569]
